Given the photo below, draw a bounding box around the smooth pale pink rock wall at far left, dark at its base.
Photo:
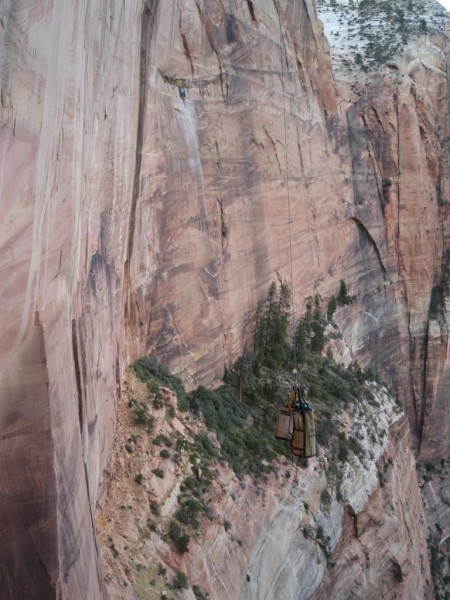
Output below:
[0,1,142,599]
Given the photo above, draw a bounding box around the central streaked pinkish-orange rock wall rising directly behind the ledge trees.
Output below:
[126,1,344,385]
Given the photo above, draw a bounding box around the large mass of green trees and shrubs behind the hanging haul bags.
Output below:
[135,281,384,506]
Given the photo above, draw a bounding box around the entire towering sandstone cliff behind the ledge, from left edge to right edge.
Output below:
[0,0,450,599]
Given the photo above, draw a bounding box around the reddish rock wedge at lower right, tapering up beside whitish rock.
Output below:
[311,418,434,600]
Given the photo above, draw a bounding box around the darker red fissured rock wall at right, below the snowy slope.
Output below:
[347,37,450,459]
